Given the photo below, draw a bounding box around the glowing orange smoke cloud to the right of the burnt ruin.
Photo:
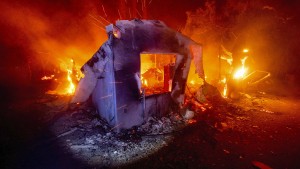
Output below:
[184,0,300,80]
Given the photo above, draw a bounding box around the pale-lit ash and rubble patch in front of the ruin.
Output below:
[51,98,188,167]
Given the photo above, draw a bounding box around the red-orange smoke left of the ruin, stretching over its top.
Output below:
[0,0,211,98]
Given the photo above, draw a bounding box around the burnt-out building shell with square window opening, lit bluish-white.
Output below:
[72,19,204,131]
